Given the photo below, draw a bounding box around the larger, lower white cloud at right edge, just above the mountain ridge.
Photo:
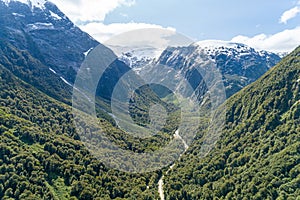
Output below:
[231,26,300,52]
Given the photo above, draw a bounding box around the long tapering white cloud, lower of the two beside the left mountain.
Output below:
[79,22,175,42]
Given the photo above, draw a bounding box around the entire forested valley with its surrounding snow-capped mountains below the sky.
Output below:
[0,0,300,200]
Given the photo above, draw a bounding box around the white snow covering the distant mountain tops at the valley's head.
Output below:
[117,40,280,73]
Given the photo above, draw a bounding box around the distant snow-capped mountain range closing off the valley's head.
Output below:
[118,40,282,97]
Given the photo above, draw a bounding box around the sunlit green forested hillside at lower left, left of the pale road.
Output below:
[0,60,161,200]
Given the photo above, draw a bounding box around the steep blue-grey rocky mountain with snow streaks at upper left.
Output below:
[0,0,137,114]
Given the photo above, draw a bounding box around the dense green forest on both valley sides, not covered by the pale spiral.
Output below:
[0,34,300,200]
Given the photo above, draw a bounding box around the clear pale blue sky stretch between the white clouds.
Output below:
[104,0,300,40]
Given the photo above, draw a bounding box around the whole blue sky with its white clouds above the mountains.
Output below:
[52,0,300,51]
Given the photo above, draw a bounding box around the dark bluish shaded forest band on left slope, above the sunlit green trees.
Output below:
[0,39,73,103]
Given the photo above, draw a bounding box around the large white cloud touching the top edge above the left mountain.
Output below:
[51,0,135,23]
